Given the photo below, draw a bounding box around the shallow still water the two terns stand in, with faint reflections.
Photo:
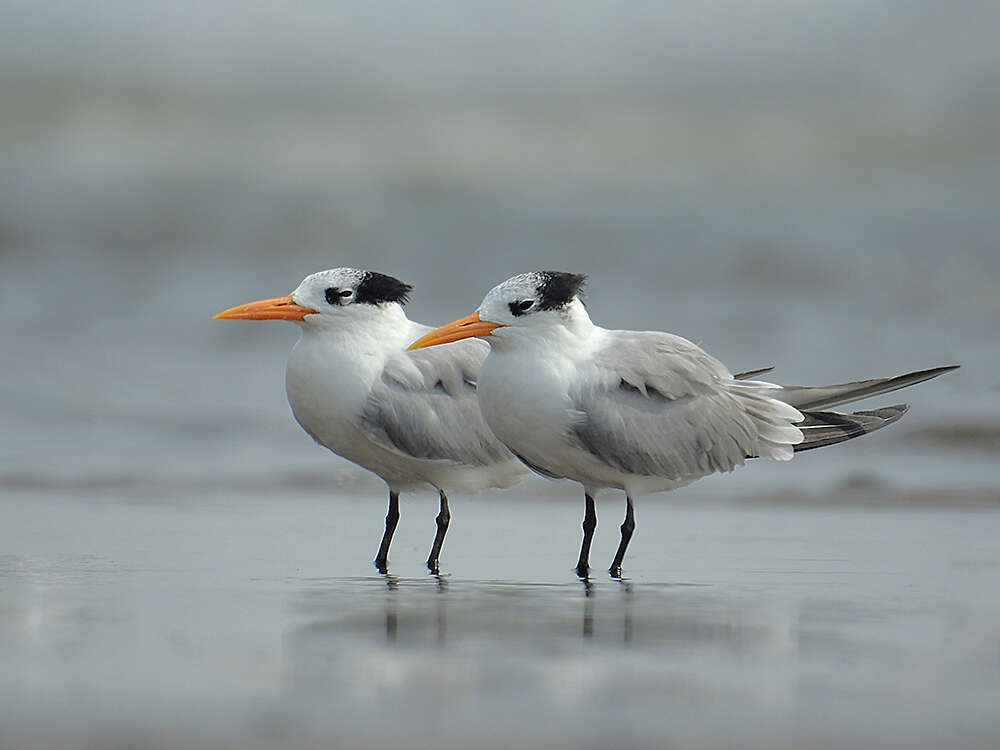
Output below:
[0,493,1000,748]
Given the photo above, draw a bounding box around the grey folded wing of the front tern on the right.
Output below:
[573,331,802,480]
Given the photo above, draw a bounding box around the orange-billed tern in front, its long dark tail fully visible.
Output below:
[410,271,956,578]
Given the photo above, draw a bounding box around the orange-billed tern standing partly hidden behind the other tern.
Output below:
[215,268,528,574]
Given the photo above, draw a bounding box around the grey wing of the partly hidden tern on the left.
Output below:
[361,339,513,466]
